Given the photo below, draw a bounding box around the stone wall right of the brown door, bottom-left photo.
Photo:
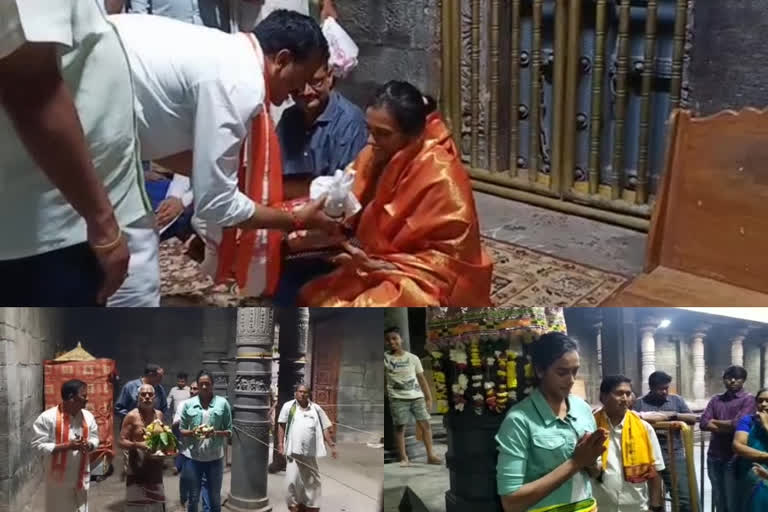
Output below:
[336,309,384,442]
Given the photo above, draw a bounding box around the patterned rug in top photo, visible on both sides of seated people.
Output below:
[160,238,630,307]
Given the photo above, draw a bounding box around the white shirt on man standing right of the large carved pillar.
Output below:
[277,400,331,457]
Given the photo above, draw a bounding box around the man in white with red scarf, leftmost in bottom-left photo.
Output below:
[32,380,99,512]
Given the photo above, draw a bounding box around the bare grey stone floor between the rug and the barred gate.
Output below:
[475,192,647,275]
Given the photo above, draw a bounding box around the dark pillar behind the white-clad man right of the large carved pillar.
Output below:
[269,308,310,473]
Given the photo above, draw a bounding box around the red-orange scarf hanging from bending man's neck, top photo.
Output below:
[216,35,283,296]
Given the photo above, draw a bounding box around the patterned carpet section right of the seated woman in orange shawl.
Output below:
[483,237,631,307]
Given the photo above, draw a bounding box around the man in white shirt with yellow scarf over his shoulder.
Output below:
[589,375,664,512]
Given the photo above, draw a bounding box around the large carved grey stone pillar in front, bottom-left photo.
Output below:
[227,308,275,512]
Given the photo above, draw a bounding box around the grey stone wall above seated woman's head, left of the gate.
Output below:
[336,0,440,105]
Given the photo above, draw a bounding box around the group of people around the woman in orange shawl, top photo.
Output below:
[0,0,492,306]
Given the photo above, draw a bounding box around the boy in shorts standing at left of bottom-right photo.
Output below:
[384,327,443,466]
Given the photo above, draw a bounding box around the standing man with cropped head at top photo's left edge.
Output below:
[0,0,152,306]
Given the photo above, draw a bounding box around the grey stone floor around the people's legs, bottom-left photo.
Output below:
[27,442,384,512]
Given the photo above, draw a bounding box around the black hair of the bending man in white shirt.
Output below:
[253,9,330,62]
